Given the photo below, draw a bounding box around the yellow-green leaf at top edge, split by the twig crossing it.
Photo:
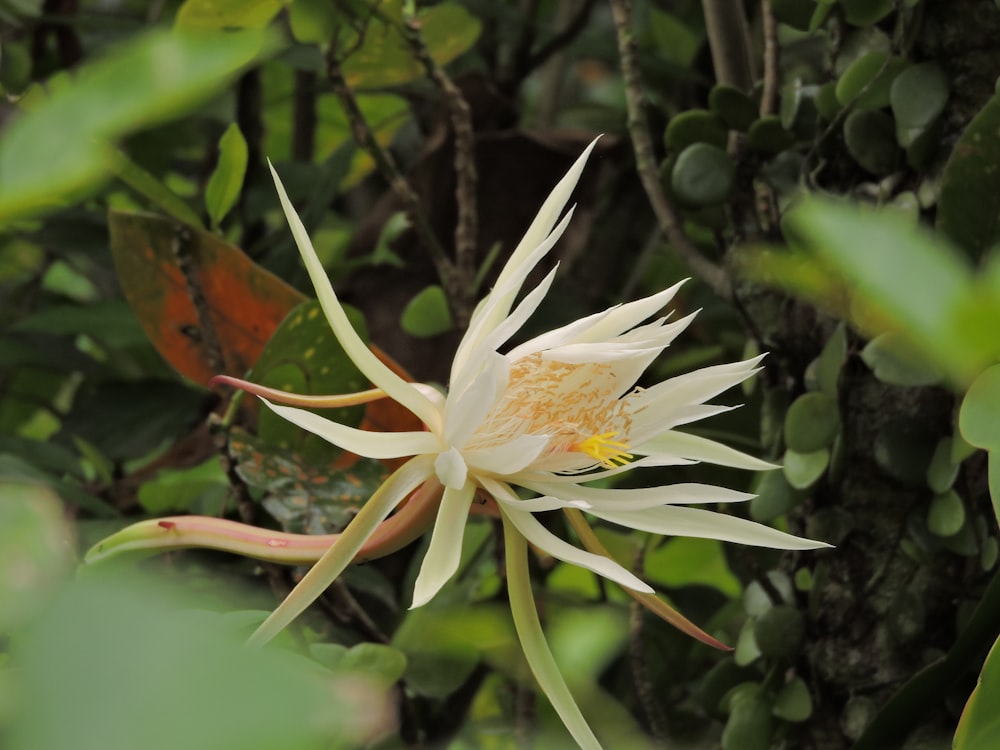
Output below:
[343,0,481,88]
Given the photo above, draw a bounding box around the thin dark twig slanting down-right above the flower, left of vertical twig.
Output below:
[326,45,452,282]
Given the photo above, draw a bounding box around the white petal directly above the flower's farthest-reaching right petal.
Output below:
[518,476,754,512]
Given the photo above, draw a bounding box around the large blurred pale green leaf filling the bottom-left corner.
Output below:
[4,577,391,750]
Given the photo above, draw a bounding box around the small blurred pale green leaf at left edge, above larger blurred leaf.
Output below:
[0,478,73,632]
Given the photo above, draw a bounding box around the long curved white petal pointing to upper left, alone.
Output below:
[268,161,440,429]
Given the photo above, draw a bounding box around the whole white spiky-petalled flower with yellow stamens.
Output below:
[236,138,825,746]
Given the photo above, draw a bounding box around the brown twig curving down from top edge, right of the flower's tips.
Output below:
[611,0,733,300]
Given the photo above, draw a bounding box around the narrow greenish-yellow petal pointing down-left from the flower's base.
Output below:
[247,456,432,646]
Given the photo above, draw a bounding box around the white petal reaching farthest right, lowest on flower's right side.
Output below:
[590,505,830,550]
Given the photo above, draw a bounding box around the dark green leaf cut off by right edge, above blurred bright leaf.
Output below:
[937,94,1000,257]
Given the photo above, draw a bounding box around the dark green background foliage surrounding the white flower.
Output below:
[0,0,1000,750]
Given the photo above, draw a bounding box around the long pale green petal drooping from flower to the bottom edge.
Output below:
[500,513,601,750]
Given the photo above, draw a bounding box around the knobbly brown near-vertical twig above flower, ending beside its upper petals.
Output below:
[404,11,479,328]
